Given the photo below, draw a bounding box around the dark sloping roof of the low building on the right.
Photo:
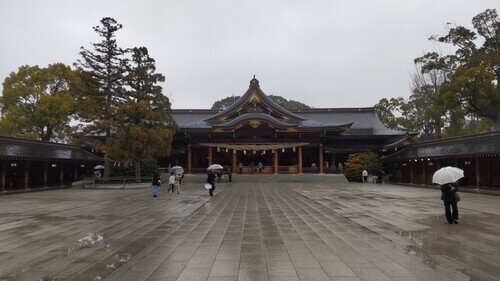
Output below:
[386,131,500,161]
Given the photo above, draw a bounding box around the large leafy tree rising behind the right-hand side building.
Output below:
[415,9,500,131]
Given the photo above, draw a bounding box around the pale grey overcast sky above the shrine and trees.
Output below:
[0,0,500,109]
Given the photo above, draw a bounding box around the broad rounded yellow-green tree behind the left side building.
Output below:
[0,63,80,142]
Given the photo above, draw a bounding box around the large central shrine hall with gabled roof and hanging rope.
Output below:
[162,77,411,174]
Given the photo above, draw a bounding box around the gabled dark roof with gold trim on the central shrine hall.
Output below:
[172,78,406,136]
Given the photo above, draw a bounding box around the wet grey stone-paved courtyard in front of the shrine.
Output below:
[0,177,500,281]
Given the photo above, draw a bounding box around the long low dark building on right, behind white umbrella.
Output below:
[384,130,500,189]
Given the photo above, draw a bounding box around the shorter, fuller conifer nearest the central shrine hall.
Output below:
[106,47,177,180]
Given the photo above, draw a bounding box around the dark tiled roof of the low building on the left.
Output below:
[0,136,103,162]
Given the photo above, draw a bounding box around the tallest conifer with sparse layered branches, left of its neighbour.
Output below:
[75,17,127,178]
